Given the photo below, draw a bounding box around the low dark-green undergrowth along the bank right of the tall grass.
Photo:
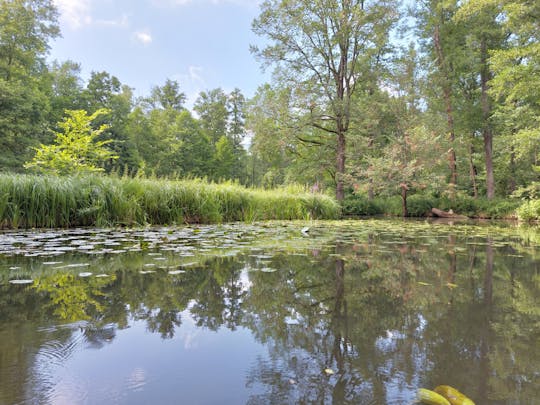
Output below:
[343,194,540,222]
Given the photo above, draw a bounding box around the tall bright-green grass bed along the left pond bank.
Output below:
[0,174,340,228]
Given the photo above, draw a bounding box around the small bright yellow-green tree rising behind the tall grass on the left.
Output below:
[25,109,117,175]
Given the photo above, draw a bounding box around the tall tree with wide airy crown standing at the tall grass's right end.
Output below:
[253,0,397,200]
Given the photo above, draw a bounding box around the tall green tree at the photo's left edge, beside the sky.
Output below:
[0,0,60,170]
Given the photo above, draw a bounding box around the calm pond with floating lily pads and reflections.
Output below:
[0,219,540,404]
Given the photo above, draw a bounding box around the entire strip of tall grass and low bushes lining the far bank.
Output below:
[0,174,540,228]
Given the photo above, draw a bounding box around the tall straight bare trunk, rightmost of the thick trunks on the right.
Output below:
[480,38,495,200]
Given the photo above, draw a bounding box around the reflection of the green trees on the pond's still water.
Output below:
[0,223,540,404]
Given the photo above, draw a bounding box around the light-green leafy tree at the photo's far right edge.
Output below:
[464,0,540,192]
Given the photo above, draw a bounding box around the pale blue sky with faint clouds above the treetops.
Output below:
[49,0,269,104]
